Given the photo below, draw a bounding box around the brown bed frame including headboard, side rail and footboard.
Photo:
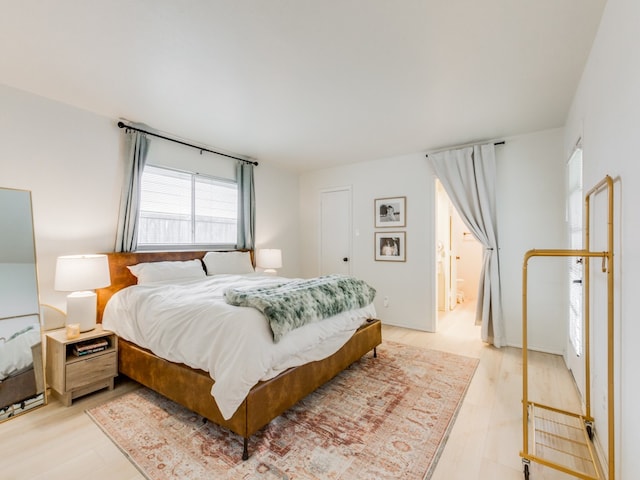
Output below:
[97,251,382,460]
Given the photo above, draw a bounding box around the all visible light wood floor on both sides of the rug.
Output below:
[0,302,592,480]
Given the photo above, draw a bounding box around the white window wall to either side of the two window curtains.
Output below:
[0,86,299,308]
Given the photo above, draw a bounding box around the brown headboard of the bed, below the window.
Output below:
[96,249,255,323]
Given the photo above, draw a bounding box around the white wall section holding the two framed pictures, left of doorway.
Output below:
[300,153,435,330]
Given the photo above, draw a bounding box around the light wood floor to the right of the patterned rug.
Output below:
[383,302,592,480]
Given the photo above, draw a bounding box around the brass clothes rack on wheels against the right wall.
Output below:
[520,175,615,480]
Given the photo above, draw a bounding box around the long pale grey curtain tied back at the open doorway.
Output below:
[428,143,505,347]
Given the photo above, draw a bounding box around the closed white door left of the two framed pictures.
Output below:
[320,187,351,275]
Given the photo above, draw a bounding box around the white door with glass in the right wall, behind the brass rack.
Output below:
[566,148,585,399]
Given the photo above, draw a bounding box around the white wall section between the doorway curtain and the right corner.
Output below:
[496,129,568,354]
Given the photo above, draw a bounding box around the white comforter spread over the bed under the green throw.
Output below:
[102,273,375,419]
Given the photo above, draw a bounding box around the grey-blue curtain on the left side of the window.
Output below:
[115,130,149,252]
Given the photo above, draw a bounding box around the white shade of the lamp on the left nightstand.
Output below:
[54,255,111,292]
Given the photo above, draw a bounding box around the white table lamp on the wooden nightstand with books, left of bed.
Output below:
[54,255,111,332]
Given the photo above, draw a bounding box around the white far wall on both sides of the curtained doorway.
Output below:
[300,129,566,346]
